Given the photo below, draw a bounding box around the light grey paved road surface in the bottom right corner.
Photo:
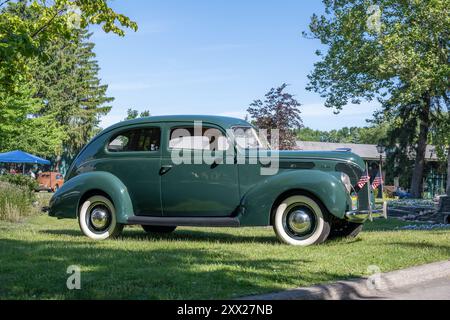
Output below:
[374,278,450,300]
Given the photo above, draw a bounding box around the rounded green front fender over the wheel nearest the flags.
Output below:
[240,170,351,226]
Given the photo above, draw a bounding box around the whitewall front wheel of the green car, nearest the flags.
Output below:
[273,195,330,246]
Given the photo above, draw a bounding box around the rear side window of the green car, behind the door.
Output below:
[108,128,161,152]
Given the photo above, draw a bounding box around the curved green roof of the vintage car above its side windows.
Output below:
[102,115,249,133]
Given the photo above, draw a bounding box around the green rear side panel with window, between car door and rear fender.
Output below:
[96,123,162,216]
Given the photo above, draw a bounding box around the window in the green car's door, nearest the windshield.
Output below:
[169,127,229,151]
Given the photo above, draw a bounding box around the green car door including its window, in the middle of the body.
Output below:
[160,122,240,217]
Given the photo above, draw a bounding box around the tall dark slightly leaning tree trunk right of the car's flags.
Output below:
[411,97,431,199]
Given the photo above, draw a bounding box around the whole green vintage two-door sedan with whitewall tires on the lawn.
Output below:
[49,116,386,246]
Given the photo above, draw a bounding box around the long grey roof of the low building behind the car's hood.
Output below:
[297,141,439,161]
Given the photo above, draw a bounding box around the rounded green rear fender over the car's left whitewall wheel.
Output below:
[49,171,133,223]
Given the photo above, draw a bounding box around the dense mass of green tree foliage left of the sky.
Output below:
[0,0,137,156]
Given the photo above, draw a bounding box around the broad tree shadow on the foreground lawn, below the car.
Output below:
[0,239,352,299]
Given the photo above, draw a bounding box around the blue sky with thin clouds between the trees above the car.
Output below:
[92,0,376,130]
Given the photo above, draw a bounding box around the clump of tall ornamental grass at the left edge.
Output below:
[0,181,36,222]
